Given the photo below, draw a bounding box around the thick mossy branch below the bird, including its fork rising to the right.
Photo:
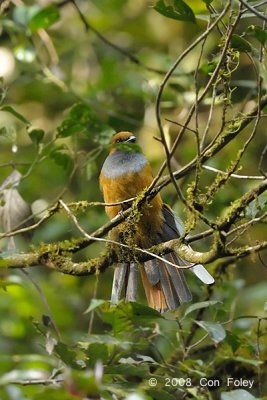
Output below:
[0,179,267,275]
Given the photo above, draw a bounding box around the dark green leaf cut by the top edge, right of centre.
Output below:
[154,0,196,24]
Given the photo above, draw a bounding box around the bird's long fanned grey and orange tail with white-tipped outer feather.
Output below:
[111,204,214,312]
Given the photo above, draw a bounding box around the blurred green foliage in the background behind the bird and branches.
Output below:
[0,0,267,400]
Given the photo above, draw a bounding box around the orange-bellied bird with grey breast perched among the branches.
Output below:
[99,131,214,313]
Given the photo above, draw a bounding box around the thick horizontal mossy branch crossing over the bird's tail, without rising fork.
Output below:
[0,235,267,276]
